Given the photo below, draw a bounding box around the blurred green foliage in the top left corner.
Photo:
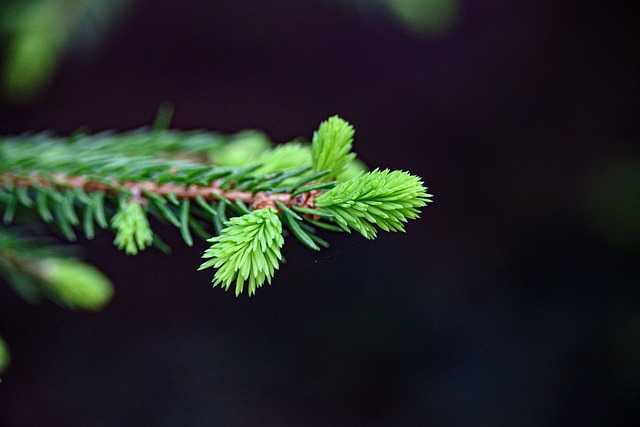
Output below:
[0,0,134,103]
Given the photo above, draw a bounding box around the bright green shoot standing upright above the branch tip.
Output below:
[311,116,356,181]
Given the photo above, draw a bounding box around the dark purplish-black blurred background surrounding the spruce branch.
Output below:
[0,0,640,426]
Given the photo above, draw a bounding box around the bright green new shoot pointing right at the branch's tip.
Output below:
[315,169,431,239]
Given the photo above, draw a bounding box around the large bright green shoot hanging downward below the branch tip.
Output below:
[200,208,284,296]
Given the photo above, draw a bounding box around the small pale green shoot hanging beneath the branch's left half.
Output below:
[111,201,153,255]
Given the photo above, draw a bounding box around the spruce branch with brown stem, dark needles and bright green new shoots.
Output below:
[0,116,431,295]
